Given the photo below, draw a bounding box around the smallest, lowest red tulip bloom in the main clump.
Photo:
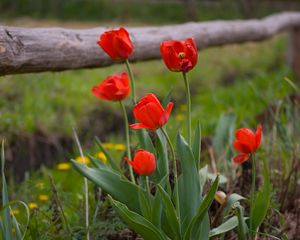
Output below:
[125,149,156,176]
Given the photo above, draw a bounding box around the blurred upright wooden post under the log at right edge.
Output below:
[287,27,300,80]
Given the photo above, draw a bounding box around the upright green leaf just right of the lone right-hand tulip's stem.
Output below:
[250,158,271,234]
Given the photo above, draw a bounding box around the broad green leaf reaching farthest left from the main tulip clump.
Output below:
[71,160,142,213]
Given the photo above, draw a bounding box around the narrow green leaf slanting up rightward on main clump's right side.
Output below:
[183,176,219,240]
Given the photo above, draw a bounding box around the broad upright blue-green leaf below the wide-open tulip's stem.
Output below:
[176,134,201,231]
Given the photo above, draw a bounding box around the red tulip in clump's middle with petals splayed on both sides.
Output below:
[130,93,174,130]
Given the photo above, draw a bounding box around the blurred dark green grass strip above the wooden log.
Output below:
[0,0,299,24]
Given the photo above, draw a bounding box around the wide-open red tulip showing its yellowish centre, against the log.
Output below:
[160,38,198,72]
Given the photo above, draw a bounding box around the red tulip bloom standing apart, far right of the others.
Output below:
[233,124,262,164]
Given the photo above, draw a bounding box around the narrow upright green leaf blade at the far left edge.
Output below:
[1,141,12,239]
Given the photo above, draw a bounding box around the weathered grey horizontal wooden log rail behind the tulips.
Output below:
[0,12,300,75]
